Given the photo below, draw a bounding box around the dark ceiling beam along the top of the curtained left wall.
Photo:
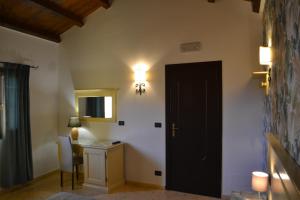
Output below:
[0,16,61,43]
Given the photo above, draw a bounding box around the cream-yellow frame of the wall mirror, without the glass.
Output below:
[75,89,117,122]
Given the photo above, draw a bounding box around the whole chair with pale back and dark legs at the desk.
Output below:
[58,136,83,190]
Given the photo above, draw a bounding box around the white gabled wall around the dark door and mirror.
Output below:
[59,0,263,194]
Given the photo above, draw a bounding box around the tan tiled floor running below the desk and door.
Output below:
[0,172,220,200]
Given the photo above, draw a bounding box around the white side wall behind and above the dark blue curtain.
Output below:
[0,27,58,177]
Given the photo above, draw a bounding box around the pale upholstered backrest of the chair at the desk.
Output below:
[58,136,73,172]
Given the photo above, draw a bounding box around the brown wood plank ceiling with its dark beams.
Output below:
[0,0,261,43]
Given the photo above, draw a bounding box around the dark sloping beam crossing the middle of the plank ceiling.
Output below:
[30,0,84,27]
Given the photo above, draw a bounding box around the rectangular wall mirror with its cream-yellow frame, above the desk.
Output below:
[75,89,116,122]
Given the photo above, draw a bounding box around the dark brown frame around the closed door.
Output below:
[165,60,223,198]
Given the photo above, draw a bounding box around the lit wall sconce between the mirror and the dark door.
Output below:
[133,63,147,95]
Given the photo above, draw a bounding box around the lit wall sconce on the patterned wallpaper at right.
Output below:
[253,46,272,95]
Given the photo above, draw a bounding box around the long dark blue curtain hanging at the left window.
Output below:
[0,63,33,188]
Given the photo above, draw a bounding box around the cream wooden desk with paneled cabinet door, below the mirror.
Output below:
[73,141,125,192]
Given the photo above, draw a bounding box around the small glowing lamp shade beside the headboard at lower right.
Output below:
[252,172,269,192]
